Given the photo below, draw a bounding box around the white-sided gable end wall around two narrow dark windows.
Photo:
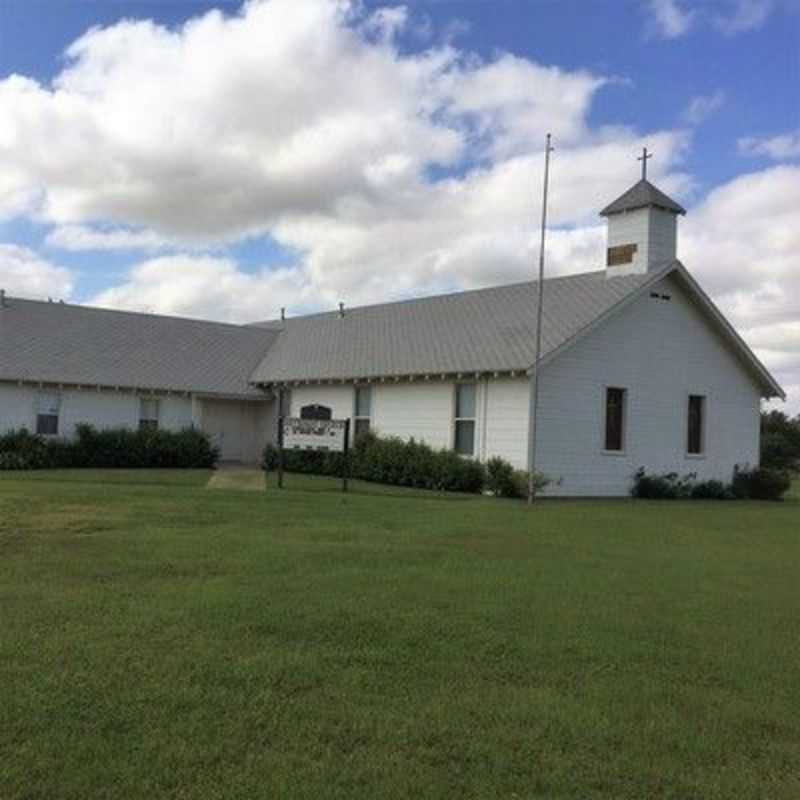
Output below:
[537,278,760,496]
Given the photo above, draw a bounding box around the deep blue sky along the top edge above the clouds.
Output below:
[0,0,800,186]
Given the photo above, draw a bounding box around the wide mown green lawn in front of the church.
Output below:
[0,471,800,800]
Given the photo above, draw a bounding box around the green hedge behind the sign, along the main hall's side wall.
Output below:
[262,432,546,497]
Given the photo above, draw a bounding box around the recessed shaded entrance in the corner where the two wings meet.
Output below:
[200,398,271,464]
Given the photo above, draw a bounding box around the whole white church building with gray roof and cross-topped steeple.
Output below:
[0,179,785,496]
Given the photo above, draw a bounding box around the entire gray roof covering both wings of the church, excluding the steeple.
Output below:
[0,261,785,397]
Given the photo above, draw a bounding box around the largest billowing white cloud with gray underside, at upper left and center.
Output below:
[0,0,616,246]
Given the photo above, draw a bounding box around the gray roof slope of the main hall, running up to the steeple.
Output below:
[251,265,671,384]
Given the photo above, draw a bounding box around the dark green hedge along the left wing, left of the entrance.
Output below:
[0,425,219,470]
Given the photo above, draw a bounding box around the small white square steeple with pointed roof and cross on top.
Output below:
[600,148,686,277]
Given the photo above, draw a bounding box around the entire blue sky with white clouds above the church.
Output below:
[0,0,800,413]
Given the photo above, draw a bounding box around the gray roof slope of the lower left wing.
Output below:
[0,297,278,396]
